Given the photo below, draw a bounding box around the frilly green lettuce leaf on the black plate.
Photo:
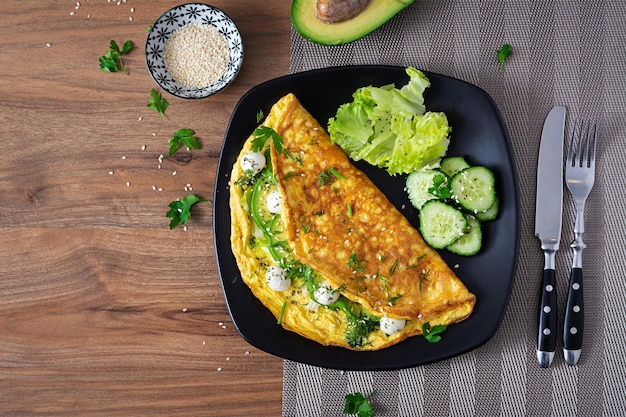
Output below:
[328,67,451,175]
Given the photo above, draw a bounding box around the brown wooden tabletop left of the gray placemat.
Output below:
[0,0,290,416]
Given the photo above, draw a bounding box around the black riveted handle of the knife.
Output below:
[537,269,557,368]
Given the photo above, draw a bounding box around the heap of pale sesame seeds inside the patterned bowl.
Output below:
[163,23,230,88]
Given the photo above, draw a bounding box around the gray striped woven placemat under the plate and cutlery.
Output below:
[283,0,626,417]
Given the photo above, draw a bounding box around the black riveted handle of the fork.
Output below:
[563,268,585,365]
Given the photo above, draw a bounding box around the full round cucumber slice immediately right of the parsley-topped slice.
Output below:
[450,166,496,214]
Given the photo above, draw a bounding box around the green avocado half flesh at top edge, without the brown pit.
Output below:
[291,0,415,45]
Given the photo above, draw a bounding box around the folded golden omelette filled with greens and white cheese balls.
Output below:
[230,94,476,350]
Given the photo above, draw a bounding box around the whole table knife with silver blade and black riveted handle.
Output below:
[535,106,566,368]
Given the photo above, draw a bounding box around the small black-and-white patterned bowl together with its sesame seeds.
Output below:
[146,3,243,99]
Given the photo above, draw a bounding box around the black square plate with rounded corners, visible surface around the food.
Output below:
[213,66,519,370]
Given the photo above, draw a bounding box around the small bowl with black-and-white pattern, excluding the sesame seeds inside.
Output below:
[146,3,243,99]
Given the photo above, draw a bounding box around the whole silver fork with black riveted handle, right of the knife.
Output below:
[563,119,597,365]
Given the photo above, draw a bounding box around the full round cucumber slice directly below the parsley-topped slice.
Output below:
[419,200,467,249]
